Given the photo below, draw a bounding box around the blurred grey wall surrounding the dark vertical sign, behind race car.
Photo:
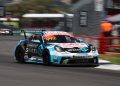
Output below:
[71,0,105,36]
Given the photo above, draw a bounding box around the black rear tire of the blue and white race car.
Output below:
[15,46,25,63]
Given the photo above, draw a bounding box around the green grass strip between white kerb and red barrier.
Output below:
[100,54,120,65]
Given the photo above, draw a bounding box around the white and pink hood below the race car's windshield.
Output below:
[49,43,88,48]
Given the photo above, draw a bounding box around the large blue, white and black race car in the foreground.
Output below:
[15,31,99,66]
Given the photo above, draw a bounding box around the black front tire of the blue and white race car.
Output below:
[43,50,51,66]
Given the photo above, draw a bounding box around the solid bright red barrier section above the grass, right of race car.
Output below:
[98,37,120,54]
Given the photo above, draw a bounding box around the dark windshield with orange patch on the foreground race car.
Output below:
[44,35,79,43]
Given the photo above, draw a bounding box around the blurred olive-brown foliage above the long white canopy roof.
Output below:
[6,0,59,17]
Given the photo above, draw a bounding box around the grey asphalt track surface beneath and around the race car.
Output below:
[0,36,120,86]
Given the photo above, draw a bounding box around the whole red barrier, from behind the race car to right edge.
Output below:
[75,35,120,54]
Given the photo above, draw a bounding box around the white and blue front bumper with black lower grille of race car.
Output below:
[51,52,99,65]
